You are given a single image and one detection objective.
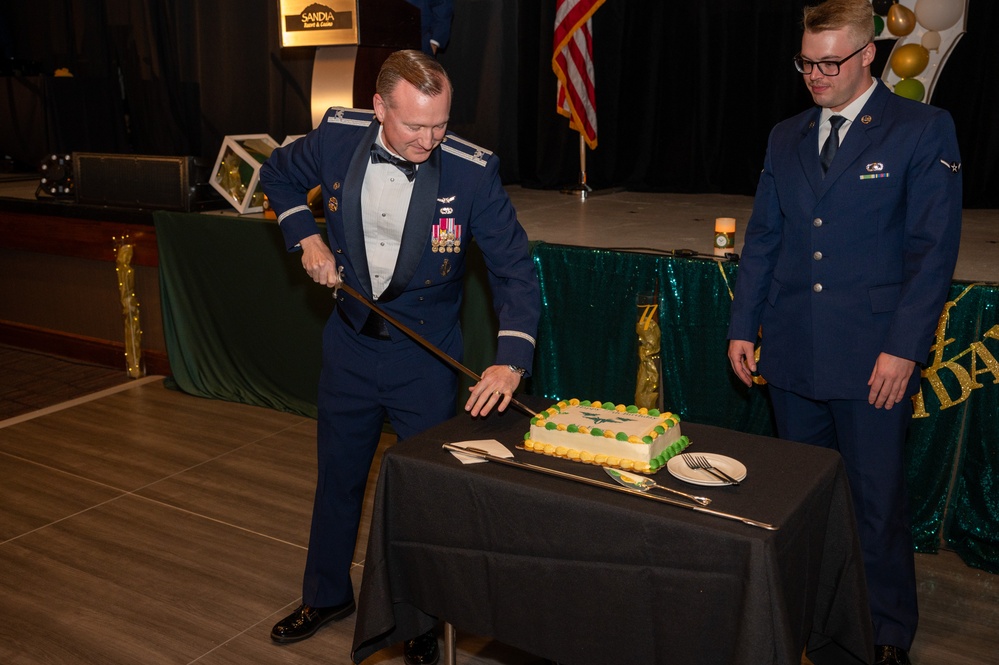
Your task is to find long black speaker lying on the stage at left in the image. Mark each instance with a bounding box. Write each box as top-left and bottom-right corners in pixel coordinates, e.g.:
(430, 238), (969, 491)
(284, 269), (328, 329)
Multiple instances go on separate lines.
(73, 152), (196, 211)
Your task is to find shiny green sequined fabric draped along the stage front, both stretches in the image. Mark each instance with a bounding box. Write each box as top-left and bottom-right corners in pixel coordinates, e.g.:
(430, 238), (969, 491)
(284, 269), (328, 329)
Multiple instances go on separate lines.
(533, 244), (999, 572)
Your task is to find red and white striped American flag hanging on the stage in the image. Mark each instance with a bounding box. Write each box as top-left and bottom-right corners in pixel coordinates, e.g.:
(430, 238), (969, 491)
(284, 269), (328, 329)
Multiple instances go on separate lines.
(552, 0), (604, 149)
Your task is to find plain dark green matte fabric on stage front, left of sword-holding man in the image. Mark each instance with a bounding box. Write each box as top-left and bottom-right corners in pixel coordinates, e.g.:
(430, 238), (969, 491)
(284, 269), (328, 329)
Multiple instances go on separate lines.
(153, 212), (333, 418)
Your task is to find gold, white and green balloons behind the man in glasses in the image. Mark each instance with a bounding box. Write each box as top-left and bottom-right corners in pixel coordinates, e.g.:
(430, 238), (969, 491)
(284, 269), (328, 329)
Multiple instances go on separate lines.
(871, 0), (970, 102)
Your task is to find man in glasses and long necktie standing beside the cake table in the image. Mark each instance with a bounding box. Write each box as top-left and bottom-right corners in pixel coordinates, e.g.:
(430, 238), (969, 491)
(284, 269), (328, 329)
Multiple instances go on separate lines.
(728, 5), (961, 664)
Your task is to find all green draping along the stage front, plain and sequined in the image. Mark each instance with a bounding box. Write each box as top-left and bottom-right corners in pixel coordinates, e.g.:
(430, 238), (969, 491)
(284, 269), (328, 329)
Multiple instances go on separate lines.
(154, 217), (999, 573)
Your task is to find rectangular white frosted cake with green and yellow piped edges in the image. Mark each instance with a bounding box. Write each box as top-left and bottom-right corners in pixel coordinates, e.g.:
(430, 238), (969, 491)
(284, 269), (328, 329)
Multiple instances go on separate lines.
(524, 399), (690, 473)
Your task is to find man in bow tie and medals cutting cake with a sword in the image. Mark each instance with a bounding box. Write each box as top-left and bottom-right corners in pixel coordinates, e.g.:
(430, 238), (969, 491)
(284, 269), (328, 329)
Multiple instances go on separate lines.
(260, 51), (540, 665)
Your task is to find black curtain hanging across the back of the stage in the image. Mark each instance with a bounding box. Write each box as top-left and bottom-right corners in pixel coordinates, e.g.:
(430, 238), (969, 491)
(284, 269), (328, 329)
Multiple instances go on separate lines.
(0, 0), (999, 208)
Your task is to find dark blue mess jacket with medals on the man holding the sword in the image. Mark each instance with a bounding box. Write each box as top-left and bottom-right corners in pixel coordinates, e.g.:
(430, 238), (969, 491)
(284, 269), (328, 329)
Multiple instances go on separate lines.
(260, 108), (541, 370)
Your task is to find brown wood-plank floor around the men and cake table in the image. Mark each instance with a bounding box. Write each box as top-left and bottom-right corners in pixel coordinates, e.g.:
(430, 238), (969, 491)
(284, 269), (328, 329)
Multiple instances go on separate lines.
(0, 367), (999, 665)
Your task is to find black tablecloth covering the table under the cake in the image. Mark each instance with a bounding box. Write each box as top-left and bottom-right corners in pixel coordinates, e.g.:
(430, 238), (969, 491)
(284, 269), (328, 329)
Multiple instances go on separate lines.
(353, 400), (872, 665)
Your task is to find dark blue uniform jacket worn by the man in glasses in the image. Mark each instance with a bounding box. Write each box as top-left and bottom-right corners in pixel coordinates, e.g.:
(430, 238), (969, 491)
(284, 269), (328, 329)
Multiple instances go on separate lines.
(728, 81), (961, 399)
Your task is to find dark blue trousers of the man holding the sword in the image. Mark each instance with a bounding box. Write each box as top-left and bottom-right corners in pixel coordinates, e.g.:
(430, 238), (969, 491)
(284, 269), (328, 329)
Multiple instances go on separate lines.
(302, 313), (462, 607)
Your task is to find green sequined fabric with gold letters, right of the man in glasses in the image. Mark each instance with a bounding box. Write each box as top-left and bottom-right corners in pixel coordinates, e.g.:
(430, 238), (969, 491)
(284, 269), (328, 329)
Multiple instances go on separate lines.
(908, 283), (999, 573)
